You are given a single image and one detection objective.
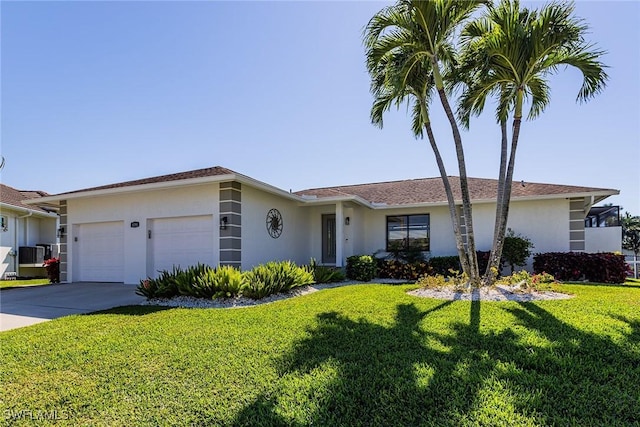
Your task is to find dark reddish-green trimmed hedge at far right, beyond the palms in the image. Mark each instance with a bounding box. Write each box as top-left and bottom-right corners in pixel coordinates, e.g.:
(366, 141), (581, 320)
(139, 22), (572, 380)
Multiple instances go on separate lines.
(533, 252), (629, 283)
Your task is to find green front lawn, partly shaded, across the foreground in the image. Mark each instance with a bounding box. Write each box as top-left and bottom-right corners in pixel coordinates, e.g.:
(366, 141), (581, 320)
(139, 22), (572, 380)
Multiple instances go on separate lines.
(0, 285), (640, 426)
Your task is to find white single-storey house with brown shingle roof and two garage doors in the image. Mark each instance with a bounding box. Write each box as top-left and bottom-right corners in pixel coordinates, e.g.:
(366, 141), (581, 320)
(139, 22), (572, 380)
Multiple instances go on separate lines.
(26, 167), (618, 283)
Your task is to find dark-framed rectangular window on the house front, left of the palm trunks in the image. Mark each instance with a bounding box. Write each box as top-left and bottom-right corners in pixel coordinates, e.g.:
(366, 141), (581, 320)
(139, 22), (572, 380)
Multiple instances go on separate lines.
(387, 214), (429, 251)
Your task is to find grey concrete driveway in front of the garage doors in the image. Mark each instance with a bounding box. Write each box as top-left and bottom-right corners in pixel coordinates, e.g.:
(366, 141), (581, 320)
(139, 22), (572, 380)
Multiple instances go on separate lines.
(0, 283), (145, 331)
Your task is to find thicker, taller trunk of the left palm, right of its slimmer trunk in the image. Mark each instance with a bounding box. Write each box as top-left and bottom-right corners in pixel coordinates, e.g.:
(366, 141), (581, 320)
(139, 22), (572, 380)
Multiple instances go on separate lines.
(432, 63), (480, 286)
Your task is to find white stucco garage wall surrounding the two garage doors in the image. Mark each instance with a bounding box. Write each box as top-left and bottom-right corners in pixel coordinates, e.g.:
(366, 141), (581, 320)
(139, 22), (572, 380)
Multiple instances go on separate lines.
(67, 183), (218, 284)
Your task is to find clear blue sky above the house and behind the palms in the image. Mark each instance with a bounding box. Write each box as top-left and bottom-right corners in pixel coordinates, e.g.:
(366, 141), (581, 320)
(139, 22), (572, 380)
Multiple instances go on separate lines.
(0, 1), (640, 214)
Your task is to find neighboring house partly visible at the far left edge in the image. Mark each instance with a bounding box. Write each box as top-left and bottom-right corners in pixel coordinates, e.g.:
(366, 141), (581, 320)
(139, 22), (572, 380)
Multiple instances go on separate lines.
(0, 184), (58, 279)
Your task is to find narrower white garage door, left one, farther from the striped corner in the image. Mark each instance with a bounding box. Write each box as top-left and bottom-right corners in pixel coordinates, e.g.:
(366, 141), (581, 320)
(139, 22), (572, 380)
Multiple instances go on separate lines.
(76, 221), (124, 282)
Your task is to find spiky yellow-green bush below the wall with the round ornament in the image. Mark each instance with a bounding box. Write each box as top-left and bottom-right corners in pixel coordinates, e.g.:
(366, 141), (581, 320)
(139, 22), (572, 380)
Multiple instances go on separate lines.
(242, 261), (313, 299)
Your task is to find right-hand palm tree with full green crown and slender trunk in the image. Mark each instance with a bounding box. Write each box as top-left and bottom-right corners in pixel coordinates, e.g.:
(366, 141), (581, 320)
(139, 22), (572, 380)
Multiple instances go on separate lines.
(458, 0), (608, 283)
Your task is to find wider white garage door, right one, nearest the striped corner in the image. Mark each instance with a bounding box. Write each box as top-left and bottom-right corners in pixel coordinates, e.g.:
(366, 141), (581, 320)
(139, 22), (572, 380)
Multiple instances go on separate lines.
(148, 215), (217, 277)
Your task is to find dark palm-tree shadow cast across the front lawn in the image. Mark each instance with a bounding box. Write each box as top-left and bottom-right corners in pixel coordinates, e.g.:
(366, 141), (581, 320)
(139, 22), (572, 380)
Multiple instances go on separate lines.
(234, 301), (640, 426)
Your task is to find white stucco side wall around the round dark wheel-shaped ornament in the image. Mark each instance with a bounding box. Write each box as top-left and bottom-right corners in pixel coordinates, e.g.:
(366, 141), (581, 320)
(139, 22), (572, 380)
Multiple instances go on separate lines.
(242, 185), (311, 270)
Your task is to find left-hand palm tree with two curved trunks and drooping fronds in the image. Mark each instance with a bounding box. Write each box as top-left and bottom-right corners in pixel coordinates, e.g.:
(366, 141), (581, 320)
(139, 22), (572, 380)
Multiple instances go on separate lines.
(365, 0), (484, 284)
